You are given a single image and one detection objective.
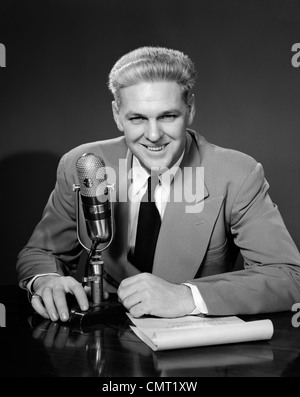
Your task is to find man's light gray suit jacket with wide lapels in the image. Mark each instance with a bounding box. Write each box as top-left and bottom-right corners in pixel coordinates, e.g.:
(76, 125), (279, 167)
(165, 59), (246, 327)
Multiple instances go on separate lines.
(17, 130), (300, 315)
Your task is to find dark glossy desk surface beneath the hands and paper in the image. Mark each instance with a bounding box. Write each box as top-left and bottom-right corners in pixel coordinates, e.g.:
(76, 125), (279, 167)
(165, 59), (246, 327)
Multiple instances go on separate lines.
(0, 287), (300, 377)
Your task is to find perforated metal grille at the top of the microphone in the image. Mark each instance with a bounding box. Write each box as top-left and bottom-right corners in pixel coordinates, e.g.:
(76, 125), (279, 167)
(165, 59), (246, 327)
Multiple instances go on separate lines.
(76, 153), (107, 197)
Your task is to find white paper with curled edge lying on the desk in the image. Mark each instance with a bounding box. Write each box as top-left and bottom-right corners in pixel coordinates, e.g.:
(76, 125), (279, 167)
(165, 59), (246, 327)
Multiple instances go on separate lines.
(128, 314), (274, 351)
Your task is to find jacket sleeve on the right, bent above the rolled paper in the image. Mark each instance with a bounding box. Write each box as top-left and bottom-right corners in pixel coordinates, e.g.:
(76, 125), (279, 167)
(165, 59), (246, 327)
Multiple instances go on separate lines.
(191, 163), (300, 315)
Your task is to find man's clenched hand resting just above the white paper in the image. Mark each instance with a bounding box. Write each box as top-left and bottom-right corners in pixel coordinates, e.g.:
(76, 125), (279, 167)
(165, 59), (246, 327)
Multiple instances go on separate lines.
(118, 273), (195, 317)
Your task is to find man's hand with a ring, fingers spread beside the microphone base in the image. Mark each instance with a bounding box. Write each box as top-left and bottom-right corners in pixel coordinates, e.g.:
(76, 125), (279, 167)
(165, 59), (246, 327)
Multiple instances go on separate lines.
(31, 275), (89, 321)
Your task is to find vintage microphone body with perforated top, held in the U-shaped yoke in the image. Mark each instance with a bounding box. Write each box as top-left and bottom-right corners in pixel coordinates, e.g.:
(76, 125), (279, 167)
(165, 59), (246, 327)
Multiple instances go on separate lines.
(76, 153), (112, 245)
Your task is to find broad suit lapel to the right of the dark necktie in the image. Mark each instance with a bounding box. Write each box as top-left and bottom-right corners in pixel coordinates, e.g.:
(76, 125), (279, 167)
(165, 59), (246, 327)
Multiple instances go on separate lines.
(153, 196), (223, 282)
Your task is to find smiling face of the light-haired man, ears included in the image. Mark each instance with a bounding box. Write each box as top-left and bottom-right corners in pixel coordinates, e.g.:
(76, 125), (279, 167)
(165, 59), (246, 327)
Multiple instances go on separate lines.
(113, 81), (195, 172)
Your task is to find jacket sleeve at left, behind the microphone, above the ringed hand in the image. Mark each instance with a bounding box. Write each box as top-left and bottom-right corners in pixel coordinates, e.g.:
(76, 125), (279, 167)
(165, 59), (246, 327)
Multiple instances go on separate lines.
(16, 155), (82, 287)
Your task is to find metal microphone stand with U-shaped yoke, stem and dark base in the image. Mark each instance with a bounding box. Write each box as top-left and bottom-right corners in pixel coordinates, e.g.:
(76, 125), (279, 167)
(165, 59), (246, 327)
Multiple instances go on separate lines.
(69, 184), (121, 325)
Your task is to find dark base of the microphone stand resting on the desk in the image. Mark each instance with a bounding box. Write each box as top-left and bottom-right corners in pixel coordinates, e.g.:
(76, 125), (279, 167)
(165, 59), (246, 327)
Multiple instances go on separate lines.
(69, 297), (125, 327)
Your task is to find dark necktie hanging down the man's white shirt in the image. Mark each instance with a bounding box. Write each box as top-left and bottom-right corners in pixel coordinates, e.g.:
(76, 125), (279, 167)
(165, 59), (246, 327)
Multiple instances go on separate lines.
(132, 176), (161, 273)
